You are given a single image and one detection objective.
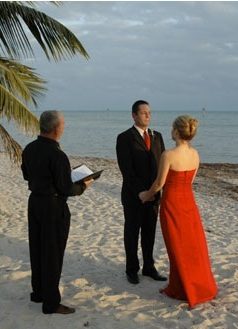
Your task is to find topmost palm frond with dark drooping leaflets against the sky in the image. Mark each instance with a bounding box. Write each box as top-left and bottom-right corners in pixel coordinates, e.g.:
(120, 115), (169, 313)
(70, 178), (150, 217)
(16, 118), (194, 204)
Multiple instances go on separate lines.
(0, 1), (89, 61)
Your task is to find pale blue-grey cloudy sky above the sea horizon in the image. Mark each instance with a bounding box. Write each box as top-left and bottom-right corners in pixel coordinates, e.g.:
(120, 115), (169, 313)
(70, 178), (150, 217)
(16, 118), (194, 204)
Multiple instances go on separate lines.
(24, 1), (238, 112)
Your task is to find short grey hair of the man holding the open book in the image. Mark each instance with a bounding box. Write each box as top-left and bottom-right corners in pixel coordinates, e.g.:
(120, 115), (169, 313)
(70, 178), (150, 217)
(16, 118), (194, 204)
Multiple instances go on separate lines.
(40, 110), (63, 133)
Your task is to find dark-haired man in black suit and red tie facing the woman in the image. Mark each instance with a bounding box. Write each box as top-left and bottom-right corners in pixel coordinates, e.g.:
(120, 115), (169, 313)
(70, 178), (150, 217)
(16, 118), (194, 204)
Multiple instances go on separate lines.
(116, 100), (166, 284)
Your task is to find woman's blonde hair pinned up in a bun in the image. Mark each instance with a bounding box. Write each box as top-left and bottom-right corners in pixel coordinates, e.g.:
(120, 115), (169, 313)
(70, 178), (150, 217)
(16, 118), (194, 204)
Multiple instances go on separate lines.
(173, 115), (198, 140)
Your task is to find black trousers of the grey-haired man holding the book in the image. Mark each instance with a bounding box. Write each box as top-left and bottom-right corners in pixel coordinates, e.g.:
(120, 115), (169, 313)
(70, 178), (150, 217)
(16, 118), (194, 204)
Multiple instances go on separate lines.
(28, 194), (70, 313)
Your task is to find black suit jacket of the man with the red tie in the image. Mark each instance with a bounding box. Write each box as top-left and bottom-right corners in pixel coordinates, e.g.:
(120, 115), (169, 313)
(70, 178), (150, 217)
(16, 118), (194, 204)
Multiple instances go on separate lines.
(116, 126), (165, 205)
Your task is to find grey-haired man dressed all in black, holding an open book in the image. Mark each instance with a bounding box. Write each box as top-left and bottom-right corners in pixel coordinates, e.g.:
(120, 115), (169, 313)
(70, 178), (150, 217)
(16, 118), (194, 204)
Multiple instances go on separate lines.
(21, 111), (93, 314)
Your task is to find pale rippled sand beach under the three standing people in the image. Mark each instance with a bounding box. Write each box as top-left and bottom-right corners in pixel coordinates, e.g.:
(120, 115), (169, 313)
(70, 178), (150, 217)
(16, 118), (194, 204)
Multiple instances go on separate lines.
(0, 153), (238, 329)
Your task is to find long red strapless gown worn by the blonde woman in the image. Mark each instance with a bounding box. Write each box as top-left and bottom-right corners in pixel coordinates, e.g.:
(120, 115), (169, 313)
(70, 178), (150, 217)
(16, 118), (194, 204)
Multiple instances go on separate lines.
(160, 169), (217, 307)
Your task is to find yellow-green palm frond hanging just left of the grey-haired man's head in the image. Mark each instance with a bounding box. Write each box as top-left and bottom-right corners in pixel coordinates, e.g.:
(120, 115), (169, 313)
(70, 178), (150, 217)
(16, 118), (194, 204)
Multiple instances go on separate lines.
(0, 84), (39, 134)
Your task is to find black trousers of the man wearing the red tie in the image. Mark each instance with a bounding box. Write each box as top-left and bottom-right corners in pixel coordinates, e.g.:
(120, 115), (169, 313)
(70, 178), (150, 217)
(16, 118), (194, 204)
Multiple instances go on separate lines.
(123, 203), (158, 274)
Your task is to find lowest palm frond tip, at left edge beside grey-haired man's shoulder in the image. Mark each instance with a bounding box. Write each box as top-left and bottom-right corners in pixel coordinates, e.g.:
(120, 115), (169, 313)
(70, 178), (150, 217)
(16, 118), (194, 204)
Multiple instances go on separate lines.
(0, 125), (22, 164)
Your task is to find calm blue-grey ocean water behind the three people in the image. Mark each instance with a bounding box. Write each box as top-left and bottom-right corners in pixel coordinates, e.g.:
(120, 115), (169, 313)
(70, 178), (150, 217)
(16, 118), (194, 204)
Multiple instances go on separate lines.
(2, 111), (238, 163)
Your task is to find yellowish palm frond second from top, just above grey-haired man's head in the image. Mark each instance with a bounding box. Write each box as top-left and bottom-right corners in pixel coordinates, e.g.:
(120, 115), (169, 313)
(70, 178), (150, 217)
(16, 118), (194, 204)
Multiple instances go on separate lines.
(0, 57), (46, 107)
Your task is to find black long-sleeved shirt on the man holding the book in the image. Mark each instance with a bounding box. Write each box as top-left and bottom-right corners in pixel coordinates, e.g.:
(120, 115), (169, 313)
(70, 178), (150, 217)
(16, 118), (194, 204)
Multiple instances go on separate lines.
(21, 136), (86, 199)
